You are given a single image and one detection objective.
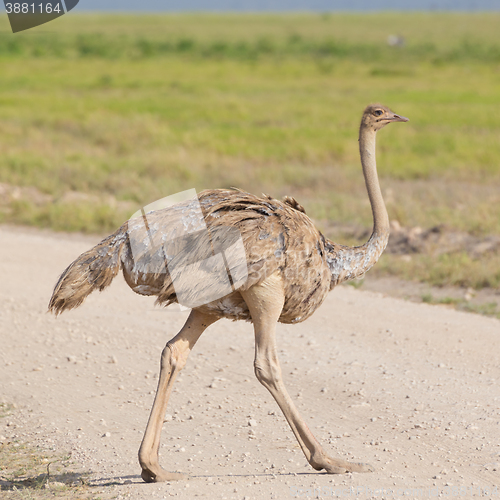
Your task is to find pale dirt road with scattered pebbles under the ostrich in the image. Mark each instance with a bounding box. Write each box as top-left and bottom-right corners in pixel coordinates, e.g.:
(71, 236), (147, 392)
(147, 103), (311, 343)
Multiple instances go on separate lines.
(0, 226), (500, 499)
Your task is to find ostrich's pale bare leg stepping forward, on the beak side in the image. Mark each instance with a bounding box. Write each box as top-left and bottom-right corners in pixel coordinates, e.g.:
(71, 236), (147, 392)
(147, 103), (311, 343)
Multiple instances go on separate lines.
(241, 275), (373, 474)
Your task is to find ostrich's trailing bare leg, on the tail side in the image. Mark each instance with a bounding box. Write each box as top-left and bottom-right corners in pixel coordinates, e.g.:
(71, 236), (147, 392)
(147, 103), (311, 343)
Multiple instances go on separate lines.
(139, 309), (218, 483)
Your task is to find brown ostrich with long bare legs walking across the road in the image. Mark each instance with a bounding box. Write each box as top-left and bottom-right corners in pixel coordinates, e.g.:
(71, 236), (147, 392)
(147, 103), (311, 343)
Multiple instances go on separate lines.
(49, 105), (408, 482)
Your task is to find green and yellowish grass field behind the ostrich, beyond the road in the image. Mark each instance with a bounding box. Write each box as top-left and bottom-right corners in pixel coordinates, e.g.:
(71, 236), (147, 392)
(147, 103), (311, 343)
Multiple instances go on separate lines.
(0, 13), (500, 288)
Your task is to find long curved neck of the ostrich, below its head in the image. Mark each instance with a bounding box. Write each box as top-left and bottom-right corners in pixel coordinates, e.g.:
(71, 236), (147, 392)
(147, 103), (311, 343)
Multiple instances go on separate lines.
(326, 125), (389, 288)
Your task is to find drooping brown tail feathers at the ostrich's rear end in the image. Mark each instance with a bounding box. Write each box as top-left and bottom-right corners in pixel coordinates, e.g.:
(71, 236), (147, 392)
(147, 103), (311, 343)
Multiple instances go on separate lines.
(49, 224), (127, 316)
